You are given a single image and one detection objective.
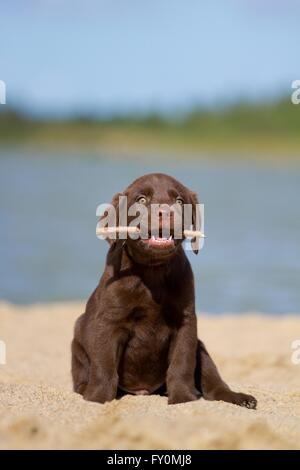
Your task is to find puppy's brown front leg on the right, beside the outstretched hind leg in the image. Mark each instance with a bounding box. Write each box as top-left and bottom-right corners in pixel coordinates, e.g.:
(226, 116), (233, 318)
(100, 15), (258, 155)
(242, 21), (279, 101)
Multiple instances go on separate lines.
(167, 313), (198, 404)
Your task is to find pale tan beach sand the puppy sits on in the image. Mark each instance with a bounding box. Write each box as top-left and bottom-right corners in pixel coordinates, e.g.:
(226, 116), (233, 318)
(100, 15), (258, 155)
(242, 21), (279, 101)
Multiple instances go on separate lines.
(0, 302), (300, 449)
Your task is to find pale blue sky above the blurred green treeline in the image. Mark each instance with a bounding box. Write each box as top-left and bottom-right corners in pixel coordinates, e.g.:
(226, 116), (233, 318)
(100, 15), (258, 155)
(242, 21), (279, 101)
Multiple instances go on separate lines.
(0, 0), (300, 115)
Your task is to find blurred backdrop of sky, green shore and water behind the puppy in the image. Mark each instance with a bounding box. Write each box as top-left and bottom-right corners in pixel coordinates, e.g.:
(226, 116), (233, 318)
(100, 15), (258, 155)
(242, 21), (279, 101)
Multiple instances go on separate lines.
(0, 0), (300, 313)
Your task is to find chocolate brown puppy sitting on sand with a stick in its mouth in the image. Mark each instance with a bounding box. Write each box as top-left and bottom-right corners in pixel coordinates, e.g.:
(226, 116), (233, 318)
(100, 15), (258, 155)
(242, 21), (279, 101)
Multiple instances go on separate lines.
(72, 173), (256, 408)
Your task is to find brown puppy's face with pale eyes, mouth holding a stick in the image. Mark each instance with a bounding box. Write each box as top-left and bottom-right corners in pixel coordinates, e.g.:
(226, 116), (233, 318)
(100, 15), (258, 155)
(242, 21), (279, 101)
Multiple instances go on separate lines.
(112, 173), (198, 264)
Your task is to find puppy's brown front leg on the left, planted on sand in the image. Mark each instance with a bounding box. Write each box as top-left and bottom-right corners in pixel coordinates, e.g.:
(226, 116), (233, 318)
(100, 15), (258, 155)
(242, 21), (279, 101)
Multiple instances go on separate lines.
(83, 327), (125, 403)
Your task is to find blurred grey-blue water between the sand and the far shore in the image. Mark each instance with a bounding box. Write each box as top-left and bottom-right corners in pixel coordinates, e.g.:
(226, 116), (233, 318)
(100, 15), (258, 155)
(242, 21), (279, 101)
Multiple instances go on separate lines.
(0, 150), (300, 313)
